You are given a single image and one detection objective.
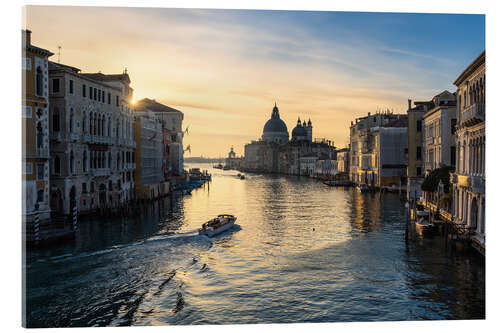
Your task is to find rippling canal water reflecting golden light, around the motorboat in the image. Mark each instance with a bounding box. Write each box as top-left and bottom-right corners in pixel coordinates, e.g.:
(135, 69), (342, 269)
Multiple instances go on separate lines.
(23, 165), (485, 327)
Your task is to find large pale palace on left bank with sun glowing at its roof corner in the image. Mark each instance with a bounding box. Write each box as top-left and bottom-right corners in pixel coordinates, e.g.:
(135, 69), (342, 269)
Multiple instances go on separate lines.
(49, 62), (135, 215)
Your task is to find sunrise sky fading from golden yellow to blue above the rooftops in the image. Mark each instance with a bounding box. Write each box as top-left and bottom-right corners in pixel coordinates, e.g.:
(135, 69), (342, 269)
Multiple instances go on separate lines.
(25, 6), (485, 157)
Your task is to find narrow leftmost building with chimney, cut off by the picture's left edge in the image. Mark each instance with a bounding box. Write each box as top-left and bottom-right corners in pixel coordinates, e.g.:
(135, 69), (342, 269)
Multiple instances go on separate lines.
(22, 30), (52, 222)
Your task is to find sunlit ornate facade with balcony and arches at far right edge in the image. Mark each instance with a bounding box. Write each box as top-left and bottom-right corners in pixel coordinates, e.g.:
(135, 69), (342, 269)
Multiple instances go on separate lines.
(451, 52), (486, 251)
